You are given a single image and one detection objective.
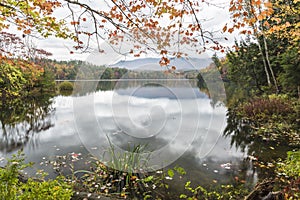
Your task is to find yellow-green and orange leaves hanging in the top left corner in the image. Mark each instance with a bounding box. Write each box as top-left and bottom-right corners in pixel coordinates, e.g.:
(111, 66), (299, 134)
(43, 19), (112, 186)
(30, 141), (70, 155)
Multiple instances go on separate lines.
(0, 0), (70, 38)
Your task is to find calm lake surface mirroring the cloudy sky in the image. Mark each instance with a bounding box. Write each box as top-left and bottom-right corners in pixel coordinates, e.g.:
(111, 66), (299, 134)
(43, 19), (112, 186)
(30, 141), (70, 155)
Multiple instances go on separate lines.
(0, 80), (257, 193)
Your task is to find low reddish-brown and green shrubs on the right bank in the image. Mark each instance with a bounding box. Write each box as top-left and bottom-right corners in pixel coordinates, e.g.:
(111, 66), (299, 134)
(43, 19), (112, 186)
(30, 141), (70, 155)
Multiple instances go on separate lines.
(224, 95), (300, 146)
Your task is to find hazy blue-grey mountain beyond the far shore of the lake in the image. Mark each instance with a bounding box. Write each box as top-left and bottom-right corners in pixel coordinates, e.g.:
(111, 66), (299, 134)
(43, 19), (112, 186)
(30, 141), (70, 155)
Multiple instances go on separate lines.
(109, 58), (212, 71)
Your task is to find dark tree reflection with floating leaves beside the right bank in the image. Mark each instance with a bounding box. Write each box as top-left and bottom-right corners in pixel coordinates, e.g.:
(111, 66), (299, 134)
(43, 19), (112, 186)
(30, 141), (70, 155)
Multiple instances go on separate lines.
(224, 108), (293, 179)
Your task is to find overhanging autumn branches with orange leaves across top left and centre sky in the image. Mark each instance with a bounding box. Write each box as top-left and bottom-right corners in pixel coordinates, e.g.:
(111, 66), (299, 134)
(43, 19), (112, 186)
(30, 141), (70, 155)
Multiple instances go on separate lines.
(0, 0), (227, 65)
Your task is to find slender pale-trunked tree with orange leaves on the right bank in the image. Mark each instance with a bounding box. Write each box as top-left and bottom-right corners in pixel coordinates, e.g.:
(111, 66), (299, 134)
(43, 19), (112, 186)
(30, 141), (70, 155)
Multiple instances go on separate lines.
(223, 0), (279, 92)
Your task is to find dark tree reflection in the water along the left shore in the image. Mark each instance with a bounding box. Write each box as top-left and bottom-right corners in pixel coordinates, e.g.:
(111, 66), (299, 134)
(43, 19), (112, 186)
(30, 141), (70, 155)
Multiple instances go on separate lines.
(0, 94), (54, 152)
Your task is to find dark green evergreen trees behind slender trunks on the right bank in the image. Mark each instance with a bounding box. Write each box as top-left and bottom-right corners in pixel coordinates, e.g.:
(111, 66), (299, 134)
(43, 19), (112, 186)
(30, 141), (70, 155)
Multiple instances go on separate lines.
(221, 30), (300, 97)
